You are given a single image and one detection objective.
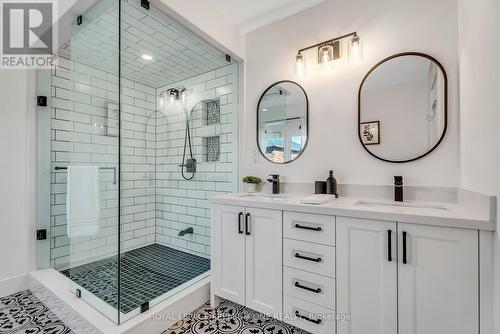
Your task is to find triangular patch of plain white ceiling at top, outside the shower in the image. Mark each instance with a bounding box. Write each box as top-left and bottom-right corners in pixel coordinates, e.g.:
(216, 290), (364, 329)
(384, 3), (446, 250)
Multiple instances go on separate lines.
(205, 0), (326, 33)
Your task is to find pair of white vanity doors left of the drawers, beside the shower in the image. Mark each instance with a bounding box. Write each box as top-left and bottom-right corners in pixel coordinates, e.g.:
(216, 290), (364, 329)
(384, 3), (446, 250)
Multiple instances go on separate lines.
(212, 205), (283, 315)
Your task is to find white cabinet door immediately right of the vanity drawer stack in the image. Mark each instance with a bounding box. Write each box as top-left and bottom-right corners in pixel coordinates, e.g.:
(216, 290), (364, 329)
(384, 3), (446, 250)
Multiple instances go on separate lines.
(337, 217), (398, 334)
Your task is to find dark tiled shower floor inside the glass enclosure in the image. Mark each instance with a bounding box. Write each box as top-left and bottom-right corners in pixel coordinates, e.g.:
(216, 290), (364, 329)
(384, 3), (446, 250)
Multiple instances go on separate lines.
(62, 244), (210, 313)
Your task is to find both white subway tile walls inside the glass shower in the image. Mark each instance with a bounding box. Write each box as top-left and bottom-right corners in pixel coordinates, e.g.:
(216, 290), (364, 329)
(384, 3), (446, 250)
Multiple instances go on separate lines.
(51, 59), (237, 268)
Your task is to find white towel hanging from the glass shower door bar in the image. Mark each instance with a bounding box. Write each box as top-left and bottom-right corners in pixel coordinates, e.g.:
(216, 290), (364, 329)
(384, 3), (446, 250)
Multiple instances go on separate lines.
(66, 166), (100, 238)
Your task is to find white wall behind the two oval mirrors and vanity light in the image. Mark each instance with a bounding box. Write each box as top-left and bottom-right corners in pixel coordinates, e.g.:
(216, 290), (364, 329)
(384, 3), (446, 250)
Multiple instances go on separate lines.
(240, 0), (459, 187)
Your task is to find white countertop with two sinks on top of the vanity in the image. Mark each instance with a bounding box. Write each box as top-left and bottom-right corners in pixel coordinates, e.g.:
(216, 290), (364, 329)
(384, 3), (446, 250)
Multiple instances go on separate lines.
(209, 193), (496, 231)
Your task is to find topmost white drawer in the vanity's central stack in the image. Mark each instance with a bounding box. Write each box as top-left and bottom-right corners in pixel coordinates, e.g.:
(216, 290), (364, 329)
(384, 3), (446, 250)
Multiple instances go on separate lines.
(283, 211), (335, 246)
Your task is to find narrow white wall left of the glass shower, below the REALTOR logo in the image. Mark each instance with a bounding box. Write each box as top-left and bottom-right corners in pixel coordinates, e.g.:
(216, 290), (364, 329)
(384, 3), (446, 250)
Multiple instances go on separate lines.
(0, 70), (35, 280)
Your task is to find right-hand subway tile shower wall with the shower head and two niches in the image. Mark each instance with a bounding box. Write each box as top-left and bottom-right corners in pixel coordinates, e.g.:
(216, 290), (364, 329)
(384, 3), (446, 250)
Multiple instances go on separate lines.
(156, 64), (237, 257)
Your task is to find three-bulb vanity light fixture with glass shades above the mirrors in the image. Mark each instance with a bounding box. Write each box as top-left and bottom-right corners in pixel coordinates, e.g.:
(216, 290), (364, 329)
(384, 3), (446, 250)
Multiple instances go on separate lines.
(295, 32), (361, 76)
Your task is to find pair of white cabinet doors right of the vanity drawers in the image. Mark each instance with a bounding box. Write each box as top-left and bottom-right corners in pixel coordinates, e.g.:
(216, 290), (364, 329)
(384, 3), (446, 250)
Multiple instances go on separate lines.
(337, 217), (479, 334)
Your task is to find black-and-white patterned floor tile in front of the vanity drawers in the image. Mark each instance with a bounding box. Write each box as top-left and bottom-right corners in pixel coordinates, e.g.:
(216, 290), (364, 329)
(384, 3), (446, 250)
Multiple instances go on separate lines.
(162, 301), (308, 334)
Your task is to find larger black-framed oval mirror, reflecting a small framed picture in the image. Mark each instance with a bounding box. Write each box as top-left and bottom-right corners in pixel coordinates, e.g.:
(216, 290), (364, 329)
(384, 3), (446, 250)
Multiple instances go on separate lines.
(358, 52), (448, 163)
